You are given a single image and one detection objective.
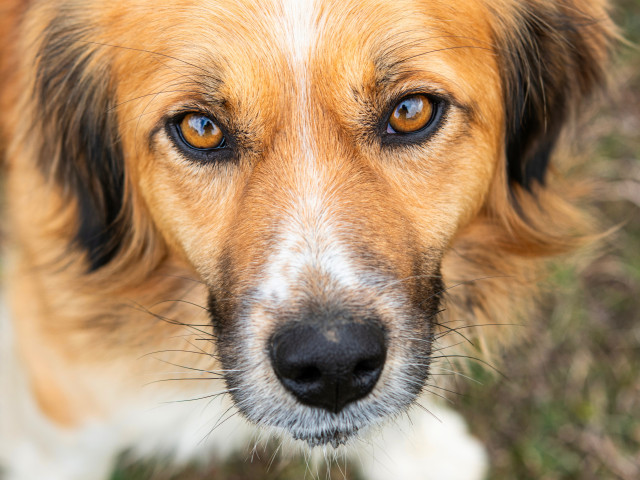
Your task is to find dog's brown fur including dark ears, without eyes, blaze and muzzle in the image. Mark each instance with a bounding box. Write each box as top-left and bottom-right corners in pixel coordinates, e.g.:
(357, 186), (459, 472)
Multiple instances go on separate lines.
(0, 0), (612, 462)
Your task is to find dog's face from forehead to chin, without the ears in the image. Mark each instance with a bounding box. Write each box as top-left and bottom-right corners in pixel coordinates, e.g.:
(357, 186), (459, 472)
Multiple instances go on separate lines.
(109, 1), (504, 444)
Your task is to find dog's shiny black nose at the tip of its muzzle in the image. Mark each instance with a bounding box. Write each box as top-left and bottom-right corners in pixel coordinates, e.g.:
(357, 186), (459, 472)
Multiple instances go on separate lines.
(271, 322), (387, 413)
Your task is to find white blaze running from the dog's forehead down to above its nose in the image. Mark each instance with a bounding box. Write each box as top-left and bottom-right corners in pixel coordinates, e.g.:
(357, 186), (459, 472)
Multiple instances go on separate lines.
(258, 0), (368, 303)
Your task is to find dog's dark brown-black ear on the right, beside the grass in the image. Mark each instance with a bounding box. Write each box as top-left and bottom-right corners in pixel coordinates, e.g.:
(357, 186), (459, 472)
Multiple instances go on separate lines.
(495, 0), (613, 191)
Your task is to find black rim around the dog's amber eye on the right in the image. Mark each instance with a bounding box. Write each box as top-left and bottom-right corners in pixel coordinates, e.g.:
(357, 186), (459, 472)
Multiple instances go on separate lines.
(378, 91), (449, 146)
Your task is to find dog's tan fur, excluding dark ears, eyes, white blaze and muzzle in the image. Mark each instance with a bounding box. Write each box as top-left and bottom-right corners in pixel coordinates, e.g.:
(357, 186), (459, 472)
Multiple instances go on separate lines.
(0, 0), (611, 468)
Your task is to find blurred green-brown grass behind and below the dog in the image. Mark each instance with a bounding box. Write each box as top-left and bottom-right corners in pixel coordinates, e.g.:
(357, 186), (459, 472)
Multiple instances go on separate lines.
(112, 0), (640, 480)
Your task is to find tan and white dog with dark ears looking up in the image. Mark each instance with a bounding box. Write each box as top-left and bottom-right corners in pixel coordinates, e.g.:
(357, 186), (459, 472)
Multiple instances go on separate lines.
(0, 0), (614, 480)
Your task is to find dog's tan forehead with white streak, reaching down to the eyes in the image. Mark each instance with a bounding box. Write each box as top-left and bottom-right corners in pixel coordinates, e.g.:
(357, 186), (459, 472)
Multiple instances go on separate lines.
(102, 0), (497, 136)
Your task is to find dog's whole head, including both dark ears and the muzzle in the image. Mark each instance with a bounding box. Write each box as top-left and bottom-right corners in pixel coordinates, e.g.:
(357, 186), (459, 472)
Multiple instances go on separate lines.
(10, 0), (604, 445)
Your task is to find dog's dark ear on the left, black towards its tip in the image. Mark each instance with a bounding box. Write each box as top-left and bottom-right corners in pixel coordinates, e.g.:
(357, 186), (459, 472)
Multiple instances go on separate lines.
(35, 16), (124, 271)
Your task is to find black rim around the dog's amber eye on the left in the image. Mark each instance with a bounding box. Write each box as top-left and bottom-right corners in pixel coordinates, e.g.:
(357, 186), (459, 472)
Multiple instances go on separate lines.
(165, 110), (234, 163)
